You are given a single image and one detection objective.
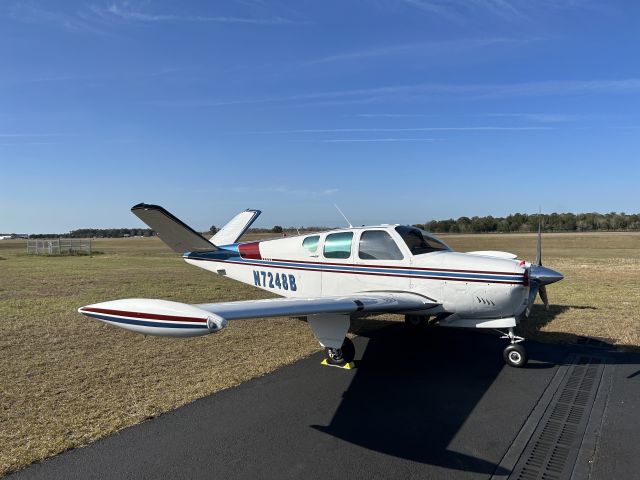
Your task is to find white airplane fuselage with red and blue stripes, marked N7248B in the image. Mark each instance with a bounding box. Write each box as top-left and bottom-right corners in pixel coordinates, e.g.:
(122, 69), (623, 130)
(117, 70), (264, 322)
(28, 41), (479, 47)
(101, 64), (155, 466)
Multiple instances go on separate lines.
(184, 225), (529, 327)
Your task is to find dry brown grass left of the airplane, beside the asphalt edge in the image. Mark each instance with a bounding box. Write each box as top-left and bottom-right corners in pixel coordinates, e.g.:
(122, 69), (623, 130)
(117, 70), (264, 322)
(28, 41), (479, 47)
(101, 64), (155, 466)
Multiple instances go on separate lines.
(0, 238), (318, 475)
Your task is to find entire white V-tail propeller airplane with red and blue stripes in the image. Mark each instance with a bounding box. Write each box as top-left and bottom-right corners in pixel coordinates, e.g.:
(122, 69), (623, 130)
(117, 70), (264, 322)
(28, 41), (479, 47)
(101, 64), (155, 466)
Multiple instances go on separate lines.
(78, 203), (563, 368)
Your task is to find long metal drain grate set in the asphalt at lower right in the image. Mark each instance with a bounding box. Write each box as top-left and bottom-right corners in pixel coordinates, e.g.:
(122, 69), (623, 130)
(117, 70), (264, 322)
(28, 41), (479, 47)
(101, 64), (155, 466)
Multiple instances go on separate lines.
(509, 355), (604, 480)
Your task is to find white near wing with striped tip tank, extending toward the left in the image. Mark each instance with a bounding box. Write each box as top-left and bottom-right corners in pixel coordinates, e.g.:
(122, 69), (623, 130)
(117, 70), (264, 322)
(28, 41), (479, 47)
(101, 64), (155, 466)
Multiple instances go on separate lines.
(78, 292), (440, 337)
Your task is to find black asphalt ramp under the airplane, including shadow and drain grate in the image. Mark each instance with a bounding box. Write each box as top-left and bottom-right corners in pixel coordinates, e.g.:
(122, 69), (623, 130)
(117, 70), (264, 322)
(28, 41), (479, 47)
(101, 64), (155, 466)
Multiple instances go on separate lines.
(11, 324), (640, 480)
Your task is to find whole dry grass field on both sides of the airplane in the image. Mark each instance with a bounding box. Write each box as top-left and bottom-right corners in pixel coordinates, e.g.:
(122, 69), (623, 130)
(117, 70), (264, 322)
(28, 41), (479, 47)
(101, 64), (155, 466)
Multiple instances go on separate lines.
(0, 233), (640, 475)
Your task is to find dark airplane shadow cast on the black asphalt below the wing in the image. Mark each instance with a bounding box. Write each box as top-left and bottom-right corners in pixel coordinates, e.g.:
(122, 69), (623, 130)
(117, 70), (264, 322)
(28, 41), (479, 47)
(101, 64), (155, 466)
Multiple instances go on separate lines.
(312, 320), (576, 475)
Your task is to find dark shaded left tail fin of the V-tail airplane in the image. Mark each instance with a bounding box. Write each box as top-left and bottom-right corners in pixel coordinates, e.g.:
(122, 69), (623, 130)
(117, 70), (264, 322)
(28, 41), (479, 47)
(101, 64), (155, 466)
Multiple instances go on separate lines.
(131, 203), (217, 253)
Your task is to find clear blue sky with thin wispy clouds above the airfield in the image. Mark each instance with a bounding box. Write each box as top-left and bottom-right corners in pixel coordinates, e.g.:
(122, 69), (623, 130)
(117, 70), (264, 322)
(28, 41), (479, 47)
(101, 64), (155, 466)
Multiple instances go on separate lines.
(0, 0), (640, 233)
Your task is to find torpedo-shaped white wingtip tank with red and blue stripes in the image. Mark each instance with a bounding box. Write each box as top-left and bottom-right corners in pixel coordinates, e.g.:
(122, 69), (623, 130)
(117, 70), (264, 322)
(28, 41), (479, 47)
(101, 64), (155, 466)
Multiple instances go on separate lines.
(78, 298), (227, 337)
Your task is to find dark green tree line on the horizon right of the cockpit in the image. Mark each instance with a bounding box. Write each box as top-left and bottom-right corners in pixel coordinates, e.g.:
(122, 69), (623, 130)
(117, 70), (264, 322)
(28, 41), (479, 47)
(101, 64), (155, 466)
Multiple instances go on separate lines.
(415, 212), (640, 233)
